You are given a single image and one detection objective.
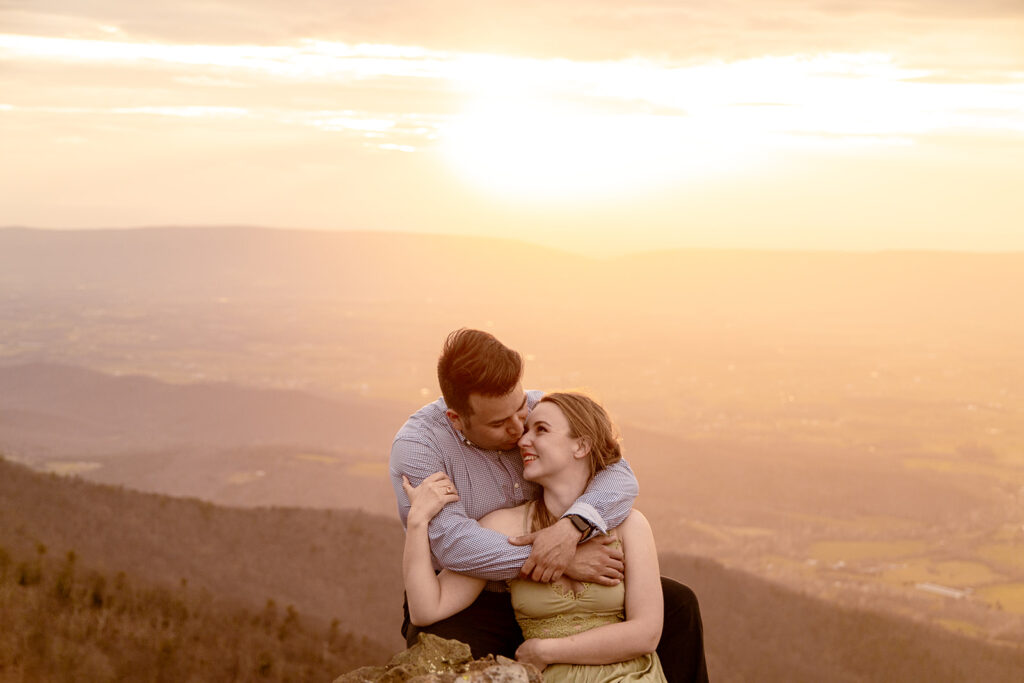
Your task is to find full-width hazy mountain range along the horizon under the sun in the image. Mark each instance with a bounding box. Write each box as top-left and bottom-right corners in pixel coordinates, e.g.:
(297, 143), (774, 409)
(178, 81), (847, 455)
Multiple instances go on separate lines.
(0, 227), (1024, 323)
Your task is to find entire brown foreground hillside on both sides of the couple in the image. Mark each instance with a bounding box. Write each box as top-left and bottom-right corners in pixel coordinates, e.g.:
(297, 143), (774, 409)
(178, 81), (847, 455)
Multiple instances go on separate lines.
(0, 461), (1024, 682)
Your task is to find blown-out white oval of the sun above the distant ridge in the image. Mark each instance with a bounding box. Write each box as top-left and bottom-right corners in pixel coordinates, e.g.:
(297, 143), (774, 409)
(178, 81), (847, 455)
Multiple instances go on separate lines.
(442, 93), (729, 203)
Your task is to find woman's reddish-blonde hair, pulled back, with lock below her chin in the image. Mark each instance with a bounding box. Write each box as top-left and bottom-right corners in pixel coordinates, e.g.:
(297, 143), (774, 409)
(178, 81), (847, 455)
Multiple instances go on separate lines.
(531, 391), (623, 530)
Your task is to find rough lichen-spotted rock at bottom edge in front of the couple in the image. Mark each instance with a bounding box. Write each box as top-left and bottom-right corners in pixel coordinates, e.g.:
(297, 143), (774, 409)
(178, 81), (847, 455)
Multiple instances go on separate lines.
(334, 633), (544, 683)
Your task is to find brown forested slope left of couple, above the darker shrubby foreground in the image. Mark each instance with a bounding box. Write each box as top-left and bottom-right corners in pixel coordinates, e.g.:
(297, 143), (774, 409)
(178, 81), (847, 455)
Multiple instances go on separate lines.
(0, 461), (401, 650)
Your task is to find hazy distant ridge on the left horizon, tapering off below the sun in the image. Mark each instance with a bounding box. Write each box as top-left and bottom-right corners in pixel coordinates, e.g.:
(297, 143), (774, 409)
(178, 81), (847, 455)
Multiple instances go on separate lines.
(0, 227), (590, 302)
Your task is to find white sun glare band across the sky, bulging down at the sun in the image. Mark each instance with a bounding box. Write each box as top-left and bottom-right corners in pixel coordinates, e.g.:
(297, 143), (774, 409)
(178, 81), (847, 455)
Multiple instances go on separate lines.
(8, 29), (1024, 214)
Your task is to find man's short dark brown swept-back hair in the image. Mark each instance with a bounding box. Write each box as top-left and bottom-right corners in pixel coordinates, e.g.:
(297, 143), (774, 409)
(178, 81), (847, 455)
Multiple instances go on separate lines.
(437, 328), (522, 420)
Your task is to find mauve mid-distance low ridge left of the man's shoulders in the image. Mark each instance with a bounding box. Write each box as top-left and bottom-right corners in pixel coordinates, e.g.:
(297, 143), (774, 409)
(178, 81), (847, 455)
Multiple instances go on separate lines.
(0, 364), (401, 457)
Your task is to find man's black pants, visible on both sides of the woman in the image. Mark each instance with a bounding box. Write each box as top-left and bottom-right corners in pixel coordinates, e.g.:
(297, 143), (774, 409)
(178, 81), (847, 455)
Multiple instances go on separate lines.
(401, 577), (708, 683)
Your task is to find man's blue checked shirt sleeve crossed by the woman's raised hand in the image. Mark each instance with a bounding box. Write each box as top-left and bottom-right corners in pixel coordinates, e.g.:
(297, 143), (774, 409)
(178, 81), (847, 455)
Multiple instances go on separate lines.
(389, 439), (532, 581)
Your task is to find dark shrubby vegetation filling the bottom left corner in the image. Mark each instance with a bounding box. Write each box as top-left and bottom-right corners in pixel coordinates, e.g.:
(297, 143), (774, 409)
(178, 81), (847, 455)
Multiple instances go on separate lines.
(0, 544), (385, 683)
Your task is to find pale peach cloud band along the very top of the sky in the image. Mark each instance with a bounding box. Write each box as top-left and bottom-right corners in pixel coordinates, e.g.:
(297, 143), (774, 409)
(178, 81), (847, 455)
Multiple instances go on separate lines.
(8, 0), (1024, 70)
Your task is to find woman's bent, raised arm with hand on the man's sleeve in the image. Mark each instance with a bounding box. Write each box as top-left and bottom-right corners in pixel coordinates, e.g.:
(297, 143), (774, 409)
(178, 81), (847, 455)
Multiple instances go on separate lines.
(401, 472), (486, 626)
